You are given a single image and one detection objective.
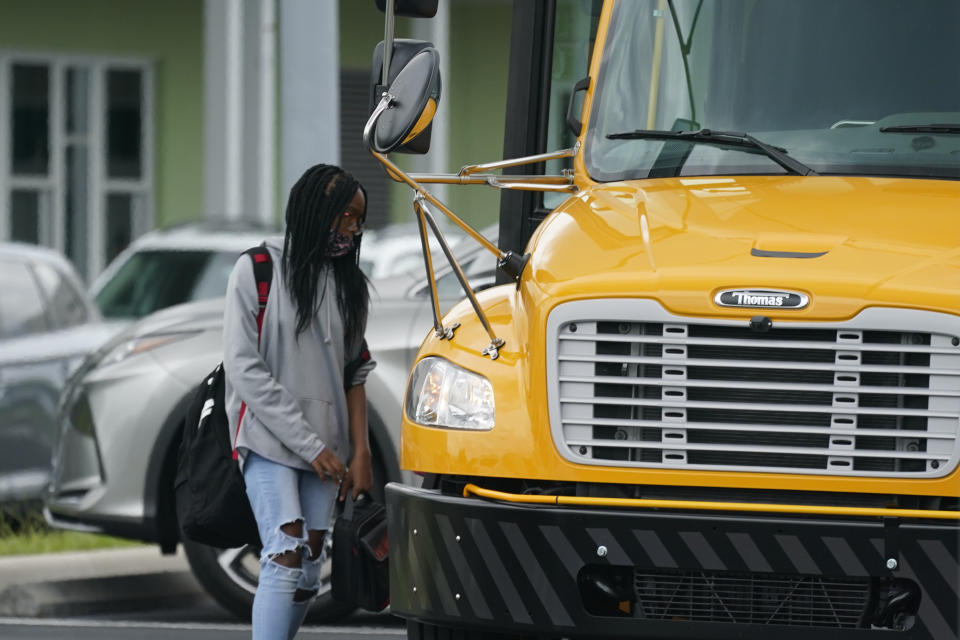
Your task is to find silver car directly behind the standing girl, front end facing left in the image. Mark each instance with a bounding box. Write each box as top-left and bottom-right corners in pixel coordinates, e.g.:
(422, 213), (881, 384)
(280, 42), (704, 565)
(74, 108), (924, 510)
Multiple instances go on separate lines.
(45, 239), (495, 621)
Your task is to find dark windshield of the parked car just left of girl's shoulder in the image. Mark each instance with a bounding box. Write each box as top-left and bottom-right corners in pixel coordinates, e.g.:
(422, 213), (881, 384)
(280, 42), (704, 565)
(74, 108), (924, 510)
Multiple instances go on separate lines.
(96, 250), (238, 318)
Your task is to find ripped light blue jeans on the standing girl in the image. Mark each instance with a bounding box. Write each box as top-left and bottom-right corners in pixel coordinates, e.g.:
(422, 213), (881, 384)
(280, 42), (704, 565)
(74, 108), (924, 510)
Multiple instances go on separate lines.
(243, 451), (338, 640)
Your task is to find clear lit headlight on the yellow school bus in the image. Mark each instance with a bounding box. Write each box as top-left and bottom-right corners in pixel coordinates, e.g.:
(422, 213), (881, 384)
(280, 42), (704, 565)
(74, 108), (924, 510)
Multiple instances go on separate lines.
(406, 357), (494, 431)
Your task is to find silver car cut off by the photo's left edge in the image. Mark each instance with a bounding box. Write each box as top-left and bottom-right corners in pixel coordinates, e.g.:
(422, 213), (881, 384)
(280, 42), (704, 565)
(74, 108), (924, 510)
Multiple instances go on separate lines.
(0, 243), (109, 503)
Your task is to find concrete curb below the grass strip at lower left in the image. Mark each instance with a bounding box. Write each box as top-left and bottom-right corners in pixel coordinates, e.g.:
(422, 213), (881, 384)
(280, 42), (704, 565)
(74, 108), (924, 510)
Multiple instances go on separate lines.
(0, 545), (210, 617)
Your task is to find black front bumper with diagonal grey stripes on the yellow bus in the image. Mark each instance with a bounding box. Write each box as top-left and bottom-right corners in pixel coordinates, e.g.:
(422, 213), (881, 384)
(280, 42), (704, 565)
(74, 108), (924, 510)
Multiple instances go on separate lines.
(387, 484), (960, 640)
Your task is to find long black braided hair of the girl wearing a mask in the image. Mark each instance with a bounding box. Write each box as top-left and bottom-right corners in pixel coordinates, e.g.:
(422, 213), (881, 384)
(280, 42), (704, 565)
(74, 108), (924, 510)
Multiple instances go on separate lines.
(282, 164), (370, 345)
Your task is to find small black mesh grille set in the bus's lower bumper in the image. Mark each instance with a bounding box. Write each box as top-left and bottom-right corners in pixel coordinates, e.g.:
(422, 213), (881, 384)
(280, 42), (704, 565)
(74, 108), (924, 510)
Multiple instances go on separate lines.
(634, 570), (870, 628)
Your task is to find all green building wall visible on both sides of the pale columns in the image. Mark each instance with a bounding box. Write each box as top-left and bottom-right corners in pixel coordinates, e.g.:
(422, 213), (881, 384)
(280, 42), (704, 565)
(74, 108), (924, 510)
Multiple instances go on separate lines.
(0, 0), (511, 241)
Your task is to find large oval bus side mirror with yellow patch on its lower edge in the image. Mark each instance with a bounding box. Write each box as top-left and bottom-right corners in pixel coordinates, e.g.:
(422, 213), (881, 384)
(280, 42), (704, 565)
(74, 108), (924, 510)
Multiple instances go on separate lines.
(363, 47), (440, 154)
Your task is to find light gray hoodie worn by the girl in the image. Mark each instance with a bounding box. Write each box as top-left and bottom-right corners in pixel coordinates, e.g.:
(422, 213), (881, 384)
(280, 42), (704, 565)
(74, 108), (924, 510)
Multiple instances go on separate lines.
(223, 240), (376, 469)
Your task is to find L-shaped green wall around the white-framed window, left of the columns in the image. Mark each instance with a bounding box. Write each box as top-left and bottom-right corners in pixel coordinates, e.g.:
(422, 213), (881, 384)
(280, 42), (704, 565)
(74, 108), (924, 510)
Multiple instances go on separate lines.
(0, 0), (203, 227)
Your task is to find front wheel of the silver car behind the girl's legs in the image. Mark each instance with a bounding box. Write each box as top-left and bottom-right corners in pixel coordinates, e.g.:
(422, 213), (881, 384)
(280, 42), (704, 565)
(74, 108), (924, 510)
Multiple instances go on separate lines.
(183, 452), (386, 624)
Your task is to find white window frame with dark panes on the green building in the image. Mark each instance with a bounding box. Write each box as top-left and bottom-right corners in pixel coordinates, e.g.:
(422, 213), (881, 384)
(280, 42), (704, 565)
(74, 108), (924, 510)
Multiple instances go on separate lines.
(0, 49), (156, 282)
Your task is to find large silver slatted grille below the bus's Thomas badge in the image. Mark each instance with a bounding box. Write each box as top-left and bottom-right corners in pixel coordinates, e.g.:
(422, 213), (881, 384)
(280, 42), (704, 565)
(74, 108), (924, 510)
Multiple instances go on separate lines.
(548, 303), (960, 477)
